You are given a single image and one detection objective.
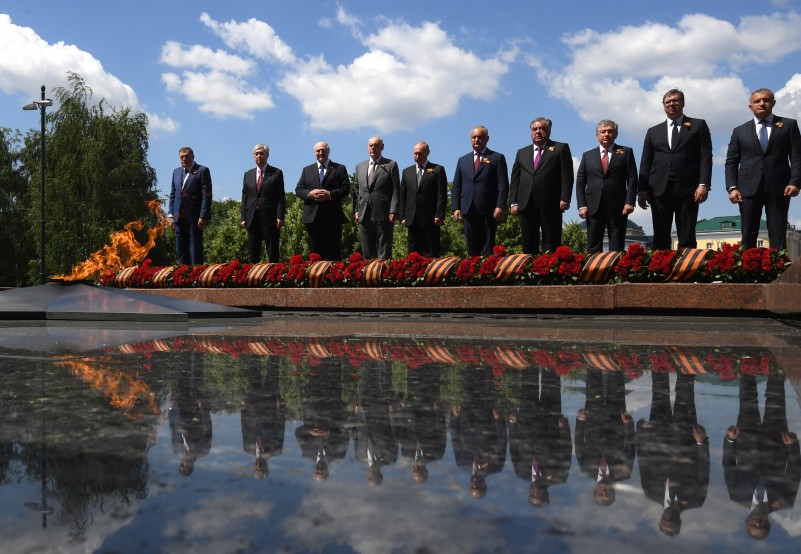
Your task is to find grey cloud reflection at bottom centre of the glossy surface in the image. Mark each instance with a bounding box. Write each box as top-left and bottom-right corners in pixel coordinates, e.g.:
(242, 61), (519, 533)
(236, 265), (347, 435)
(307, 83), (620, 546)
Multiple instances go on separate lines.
(284, 482), (506, 553)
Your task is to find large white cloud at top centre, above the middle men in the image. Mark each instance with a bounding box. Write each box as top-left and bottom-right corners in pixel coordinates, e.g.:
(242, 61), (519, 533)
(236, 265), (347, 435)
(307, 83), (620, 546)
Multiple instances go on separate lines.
(279, 19), (510, 132)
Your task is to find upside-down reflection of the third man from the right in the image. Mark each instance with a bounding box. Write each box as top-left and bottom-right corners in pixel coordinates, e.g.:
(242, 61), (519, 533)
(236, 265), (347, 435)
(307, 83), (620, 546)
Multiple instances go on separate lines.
(575, 369), (636, 506)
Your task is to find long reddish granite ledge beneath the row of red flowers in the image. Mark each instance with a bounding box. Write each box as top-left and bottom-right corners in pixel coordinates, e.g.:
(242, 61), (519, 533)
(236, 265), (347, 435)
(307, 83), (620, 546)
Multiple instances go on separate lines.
(130, 283), (776, 314)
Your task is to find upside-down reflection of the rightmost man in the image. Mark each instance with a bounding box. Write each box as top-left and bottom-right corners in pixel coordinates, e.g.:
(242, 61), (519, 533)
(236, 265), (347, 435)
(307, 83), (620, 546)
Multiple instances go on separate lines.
(723, 375), (801, 539)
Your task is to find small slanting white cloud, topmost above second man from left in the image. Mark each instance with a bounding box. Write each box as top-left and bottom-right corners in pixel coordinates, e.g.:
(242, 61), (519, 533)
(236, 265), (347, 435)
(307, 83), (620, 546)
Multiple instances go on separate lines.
(200, 13), (295, 64)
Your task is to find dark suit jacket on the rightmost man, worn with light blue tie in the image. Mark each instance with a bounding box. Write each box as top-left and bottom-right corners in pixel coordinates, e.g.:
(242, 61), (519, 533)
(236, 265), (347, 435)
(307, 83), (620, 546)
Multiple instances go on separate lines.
(726, 115), (801, 197)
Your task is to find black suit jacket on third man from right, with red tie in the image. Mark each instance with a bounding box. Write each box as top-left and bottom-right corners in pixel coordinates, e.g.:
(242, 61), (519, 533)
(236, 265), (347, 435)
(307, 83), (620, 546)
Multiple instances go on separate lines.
(576, 144), (637, 215)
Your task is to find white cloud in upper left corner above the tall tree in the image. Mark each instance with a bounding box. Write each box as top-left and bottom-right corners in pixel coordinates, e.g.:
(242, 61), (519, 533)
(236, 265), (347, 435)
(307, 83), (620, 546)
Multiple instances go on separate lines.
(0, 14), (176, 135)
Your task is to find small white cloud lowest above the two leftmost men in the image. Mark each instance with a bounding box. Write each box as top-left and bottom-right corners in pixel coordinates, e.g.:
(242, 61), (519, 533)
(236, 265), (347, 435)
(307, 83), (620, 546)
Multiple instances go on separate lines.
(161, 70), (274, 119)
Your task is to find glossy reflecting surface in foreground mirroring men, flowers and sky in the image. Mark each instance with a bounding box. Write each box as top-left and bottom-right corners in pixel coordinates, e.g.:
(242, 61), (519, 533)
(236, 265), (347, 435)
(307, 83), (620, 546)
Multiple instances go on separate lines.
(0, 314), (801, 553)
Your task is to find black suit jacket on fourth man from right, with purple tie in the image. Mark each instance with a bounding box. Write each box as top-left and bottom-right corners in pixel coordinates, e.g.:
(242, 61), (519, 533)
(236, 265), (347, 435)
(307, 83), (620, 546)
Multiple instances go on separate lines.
(510, 140), (573, 212)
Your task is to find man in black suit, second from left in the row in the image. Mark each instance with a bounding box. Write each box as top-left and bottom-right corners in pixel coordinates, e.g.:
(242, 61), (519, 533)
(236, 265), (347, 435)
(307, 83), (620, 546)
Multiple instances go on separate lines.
(240, 144), (286, 264)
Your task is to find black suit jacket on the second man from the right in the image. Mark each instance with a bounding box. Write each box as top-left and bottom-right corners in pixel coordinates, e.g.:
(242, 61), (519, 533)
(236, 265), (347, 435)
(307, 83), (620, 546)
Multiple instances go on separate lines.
(639, 116), (712, 197)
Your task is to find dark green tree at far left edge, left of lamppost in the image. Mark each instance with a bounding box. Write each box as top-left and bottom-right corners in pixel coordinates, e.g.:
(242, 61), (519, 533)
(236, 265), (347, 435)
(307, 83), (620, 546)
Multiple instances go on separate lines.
(0, 128), (38, 286)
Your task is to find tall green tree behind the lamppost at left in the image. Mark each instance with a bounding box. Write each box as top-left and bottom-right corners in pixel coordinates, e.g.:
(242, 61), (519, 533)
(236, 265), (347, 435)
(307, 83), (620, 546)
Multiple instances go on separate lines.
(23, 73), (158, 277)
